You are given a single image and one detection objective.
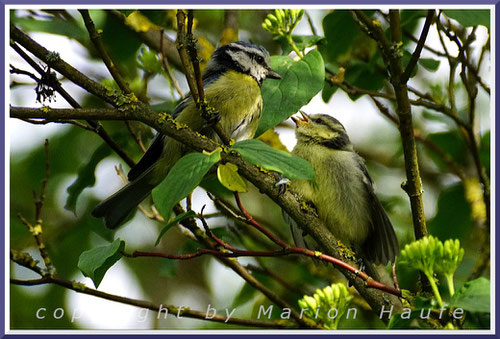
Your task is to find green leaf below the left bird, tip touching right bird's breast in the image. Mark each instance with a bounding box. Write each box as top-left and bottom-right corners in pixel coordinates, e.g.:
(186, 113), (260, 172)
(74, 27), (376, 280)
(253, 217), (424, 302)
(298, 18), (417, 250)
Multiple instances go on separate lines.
(230, 139), (314, 180)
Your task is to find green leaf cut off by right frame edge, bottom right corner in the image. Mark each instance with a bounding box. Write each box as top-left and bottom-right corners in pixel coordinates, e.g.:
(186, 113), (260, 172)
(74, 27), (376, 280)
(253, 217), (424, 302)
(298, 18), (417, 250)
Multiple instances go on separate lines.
(450, 277), (491, 313)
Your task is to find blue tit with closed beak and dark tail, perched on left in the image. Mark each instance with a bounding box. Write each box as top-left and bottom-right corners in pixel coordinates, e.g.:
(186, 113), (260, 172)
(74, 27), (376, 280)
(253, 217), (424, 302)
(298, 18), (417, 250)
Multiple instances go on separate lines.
(92, 41), (281, 229)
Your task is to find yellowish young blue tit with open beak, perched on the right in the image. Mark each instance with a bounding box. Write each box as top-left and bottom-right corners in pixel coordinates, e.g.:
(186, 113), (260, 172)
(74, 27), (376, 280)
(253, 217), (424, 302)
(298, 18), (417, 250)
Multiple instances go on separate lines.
(285, 112), (399, 280)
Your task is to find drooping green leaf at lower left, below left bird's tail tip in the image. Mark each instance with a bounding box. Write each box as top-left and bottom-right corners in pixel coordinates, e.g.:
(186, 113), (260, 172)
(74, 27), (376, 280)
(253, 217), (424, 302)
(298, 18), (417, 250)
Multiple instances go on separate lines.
(78, 239), (125, 288)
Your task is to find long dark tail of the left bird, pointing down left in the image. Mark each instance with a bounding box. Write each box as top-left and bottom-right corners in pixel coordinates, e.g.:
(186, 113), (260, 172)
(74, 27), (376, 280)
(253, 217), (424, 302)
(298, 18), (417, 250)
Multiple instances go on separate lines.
(92, 175), (154, 229)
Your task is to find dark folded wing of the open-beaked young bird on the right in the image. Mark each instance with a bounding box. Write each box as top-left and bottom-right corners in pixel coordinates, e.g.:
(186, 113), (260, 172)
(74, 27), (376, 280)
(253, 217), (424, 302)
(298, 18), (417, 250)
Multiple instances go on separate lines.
(358, 157), (399, 265)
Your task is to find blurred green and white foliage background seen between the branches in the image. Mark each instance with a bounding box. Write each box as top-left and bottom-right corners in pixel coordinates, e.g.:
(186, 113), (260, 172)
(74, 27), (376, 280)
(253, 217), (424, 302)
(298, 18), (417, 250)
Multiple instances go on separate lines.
(9, 10), (490, 329)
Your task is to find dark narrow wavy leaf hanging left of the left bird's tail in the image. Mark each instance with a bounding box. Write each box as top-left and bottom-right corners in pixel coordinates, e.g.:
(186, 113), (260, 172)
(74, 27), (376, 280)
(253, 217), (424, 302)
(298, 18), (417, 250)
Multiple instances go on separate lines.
(64, 144), (111, 213)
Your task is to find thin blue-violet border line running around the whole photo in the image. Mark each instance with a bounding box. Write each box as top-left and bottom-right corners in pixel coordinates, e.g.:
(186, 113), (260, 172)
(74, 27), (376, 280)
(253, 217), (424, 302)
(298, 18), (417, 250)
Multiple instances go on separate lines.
(0, 0), (500, 339)
